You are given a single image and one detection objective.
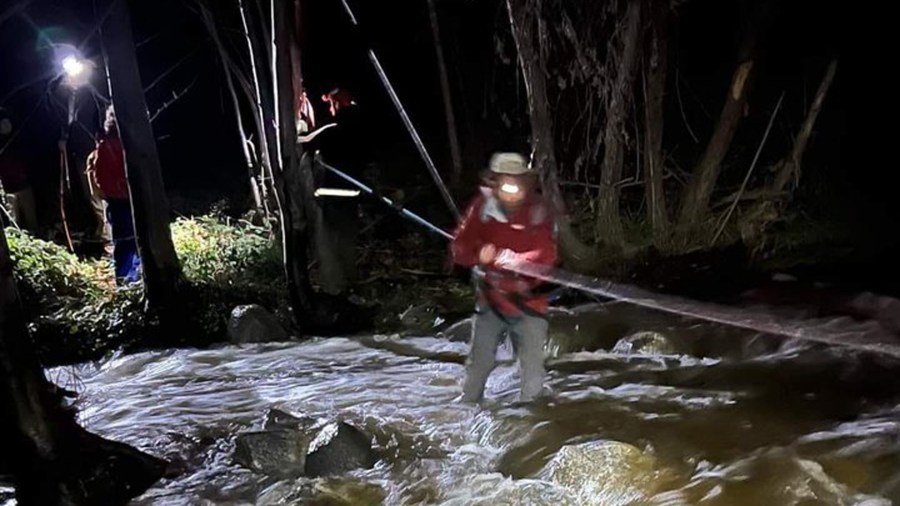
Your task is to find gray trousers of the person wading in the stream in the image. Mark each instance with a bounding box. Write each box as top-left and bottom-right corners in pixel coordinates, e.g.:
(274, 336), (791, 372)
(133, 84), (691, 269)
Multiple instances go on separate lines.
(463, 308), (548, 402)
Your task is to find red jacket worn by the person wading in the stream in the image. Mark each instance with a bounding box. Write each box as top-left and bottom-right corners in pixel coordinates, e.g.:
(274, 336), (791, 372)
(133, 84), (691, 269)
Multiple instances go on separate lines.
(450, 192), (557, 316)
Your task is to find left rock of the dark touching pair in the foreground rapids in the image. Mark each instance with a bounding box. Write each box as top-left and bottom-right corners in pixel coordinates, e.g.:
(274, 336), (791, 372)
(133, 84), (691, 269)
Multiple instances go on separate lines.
(234, 429), (310, 477)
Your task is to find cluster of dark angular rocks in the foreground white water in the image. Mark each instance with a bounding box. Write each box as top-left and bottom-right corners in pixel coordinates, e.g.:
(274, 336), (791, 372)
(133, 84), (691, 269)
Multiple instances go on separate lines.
(235, 409), (378, 477)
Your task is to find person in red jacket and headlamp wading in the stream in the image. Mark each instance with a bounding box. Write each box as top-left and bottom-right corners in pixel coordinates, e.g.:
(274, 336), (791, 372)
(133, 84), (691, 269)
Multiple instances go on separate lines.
(450, 153), (557, 403)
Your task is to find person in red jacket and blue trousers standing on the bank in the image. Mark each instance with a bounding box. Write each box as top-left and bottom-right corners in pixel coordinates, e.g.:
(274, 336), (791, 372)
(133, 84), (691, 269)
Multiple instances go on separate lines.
(87, 107), (141, 285)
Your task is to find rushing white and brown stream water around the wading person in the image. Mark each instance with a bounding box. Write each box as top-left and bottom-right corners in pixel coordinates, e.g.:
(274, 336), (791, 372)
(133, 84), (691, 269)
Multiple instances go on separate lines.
(35, 304), (900, 506)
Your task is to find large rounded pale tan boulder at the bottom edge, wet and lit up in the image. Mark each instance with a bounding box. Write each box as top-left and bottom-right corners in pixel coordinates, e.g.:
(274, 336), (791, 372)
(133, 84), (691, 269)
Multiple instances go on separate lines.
(542, 441), (657, 506)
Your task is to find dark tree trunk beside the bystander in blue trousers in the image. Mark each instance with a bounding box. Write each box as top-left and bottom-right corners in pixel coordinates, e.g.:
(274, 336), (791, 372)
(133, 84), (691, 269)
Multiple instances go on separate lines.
(101, 0), (181, 310)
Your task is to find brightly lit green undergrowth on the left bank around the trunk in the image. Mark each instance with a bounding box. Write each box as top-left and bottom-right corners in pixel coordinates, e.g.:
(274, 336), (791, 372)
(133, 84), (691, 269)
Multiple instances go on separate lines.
(6, 217), (286, 363)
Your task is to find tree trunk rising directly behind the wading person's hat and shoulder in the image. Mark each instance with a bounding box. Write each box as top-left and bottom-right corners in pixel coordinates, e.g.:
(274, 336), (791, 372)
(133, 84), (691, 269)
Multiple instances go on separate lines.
(506, 0), (598, 271)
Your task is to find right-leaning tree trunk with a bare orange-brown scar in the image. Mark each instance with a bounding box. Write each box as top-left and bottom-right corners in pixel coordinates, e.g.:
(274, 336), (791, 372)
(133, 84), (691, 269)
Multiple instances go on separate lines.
(678, 2), (766, 235)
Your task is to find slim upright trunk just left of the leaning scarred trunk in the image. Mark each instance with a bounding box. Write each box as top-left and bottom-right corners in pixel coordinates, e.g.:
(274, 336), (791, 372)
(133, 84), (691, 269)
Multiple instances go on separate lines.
(644, 0), (669, 244)
